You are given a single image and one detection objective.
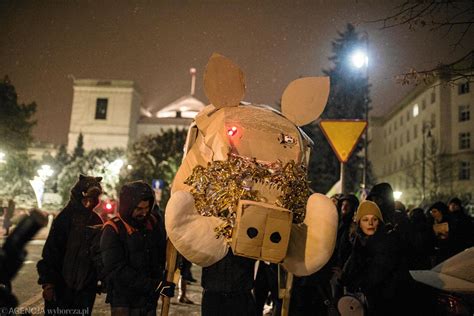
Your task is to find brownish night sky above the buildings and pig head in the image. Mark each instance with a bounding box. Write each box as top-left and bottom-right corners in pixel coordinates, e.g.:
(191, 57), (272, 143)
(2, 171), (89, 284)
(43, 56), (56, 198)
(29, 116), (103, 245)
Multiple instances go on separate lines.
(0, 0), (474, 144)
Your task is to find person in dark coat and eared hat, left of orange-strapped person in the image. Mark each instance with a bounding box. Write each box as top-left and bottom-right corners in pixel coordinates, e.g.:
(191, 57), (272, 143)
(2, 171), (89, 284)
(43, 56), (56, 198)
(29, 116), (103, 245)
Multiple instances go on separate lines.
(37, 175), (102, 315)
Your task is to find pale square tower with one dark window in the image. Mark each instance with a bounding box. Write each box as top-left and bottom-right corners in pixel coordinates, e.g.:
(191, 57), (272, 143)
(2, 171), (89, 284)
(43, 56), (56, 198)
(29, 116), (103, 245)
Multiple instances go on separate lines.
(68, 79), (142, 152)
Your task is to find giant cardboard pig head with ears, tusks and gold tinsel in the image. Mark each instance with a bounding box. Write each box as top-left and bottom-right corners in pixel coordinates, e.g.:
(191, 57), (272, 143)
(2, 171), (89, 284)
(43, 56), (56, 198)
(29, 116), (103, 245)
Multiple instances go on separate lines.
(165, 54), (338, 276)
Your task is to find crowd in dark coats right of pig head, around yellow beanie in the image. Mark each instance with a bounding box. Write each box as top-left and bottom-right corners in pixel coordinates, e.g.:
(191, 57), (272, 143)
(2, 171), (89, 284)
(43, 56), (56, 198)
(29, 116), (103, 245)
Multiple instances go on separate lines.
(256, 183), (474, 315)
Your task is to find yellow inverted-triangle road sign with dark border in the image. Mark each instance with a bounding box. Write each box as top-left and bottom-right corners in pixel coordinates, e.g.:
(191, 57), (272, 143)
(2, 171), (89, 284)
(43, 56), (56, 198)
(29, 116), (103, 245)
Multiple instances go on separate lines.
(319, 120), (367, 163)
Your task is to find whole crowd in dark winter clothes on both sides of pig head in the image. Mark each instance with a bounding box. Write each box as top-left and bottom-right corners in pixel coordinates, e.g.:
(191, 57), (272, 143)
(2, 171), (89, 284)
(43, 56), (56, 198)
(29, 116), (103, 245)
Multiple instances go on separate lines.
(3, 175), (466, 315)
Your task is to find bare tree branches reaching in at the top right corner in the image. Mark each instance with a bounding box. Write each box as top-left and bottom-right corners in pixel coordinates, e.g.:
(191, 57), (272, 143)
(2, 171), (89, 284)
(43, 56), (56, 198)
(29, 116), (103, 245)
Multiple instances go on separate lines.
(369, 0), (474, 84)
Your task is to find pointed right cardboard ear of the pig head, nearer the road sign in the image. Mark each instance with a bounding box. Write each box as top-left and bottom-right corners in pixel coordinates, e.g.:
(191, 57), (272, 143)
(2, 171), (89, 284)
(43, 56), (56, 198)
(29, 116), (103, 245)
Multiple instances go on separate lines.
(281, 77), (329, 126)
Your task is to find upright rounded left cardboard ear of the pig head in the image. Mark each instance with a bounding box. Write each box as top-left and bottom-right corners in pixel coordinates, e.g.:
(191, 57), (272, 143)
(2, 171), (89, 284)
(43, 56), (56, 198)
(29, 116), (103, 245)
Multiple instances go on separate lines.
(204, 53), (245, 108)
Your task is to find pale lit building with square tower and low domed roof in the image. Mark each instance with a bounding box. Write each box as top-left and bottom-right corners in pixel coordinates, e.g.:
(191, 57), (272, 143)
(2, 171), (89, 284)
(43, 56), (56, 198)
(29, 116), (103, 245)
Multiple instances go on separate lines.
(67, 79), (204, 152)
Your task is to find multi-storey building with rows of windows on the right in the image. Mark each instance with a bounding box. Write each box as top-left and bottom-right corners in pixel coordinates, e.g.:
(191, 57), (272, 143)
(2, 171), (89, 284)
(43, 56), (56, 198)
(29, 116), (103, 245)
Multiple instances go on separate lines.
(369, 79), (474, 206)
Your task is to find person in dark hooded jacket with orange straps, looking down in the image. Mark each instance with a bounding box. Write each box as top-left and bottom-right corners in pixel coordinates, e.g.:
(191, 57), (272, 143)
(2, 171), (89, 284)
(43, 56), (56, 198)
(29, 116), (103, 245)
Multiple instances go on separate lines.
(100, 181), (175, 316)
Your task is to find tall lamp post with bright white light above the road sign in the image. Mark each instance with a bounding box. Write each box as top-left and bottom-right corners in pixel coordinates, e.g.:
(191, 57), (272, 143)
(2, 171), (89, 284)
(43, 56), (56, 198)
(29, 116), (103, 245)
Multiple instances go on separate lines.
(351, 31), (369, 191)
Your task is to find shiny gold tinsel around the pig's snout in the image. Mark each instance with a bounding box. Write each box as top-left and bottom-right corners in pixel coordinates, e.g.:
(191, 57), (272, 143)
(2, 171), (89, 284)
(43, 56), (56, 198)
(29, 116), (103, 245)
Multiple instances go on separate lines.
(185, 154), (311, 240)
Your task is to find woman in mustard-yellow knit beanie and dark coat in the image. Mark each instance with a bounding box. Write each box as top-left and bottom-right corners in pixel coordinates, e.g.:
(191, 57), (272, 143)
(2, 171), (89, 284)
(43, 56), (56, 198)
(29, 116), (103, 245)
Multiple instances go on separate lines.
(341, 201), (412, 315)
